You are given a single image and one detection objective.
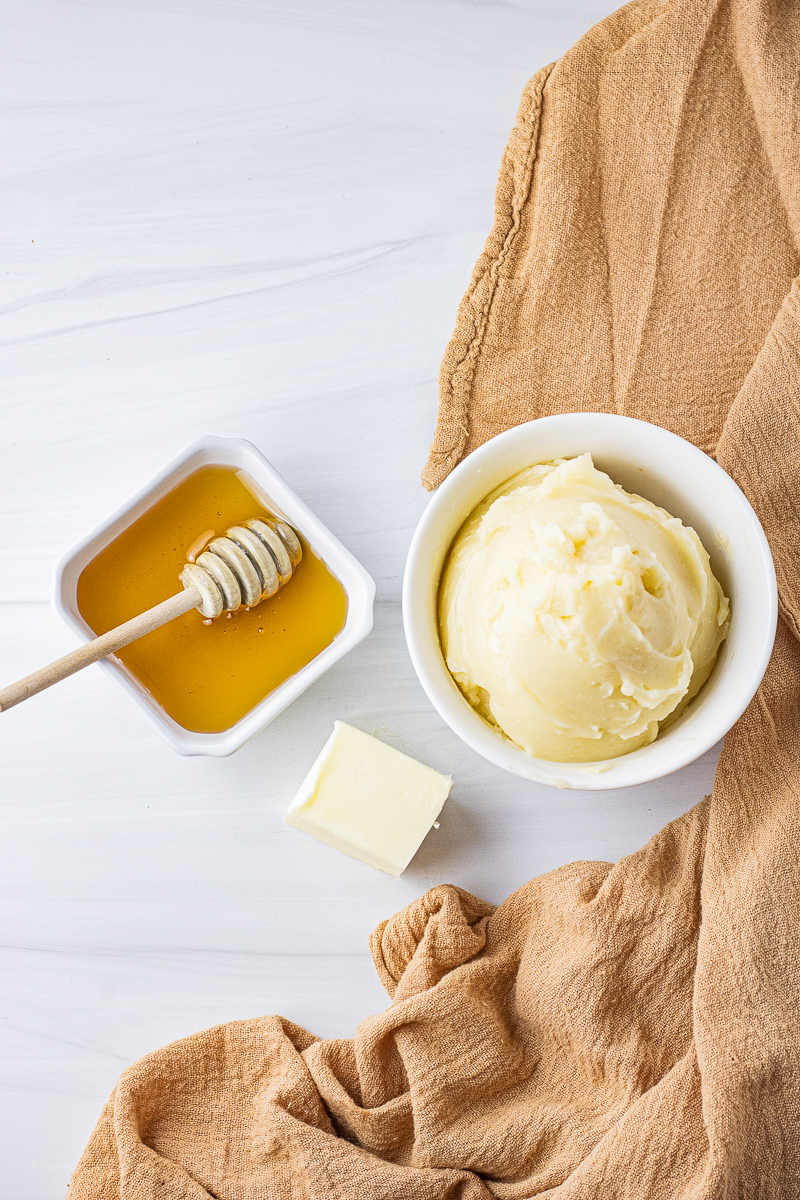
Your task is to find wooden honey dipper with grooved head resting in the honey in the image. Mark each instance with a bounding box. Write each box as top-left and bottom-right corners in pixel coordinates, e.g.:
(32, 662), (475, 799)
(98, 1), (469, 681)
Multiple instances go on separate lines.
(0, 517), (302, 712)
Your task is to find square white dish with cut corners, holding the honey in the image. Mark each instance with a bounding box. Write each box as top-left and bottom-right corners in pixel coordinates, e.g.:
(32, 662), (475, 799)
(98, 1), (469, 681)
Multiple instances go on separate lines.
(53, 437), (375, 757)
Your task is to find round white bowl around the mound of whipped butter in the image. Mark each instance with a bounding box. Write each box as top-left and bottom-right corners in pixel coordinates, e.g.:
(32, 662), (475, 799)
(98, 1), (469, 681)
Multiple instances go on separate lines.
(403, 413), (777, 791)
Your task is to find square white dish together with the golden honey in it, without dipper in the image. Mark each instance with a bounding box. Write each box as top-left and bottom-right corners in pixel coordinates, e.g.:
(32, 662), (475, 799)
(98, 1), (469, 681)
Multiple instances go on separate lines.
(55, 438), (374, 754)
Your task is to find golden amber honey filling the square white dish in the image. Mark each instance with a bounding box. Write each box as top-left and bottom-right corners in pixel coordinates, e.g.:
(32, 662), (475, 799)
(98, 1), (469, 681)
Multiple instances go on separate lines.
(78, 467), (347, 733)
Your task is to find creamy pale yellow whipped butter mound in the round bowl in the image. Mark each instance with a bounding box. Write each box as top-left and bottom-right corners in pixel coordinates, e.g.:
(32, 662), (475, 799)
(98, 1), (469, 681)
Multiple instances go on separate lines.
(439, 454), (729, 762)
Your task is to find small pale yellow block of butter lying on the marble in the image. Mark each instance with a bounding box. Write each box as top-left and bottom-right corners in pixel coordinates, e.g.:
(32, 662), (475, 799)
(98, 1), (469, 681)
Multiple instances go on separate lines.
(283, 721), (452, 880)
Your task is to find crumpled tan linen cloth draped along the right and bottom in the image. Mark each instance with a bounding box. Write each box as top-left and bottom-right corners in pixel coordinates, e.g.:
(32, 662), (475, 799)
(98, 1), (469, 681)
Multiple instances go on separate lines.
(70, 0), (800, 1200)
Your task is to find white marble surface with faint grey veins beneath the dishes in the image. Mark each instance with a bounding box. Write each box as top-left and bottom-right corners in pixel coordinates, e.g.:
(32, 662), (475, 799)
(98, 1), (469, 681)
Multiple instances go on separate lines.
(0, 0), (716, 1200)
